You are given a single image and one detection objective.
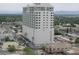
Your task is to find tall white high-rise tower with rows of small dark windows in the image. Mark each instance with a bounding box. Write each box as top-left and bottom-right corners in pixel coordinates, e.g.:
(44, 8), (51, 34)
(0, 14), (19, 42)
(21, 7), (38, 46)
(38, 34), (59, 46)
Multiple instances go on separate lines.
(23, 3), (54, 45)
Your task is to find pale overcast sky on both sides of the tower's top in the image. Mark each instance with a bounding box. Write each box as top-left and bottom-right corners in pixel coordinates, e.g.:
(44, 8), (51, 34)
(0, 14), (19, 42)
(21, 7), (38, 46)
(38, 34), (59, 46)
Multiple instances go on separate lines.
(0, 3), (79, 14)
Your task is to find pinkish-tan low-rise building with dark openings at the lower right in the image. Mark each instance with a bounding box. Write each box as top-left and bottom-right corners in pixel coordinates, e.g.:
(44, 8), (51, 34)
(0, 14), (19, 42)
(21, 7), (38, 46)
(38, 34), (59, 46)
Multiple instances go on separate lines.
(46, 42), (72, 53)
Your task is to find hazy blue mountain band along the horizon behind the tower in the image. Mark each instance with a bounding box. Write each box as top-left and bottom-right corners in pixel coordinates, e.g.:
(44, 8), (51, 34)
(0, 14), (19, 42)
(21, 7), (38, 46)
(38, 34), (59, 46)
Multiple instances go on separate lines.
(0, 11), (79, 16)
